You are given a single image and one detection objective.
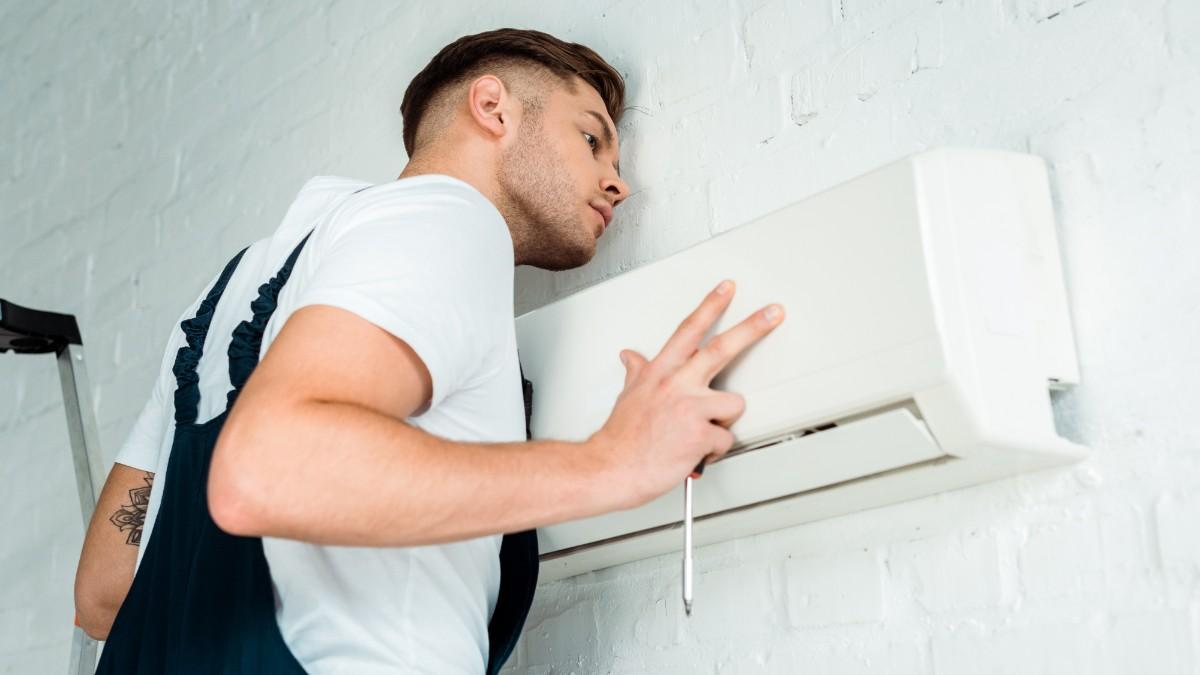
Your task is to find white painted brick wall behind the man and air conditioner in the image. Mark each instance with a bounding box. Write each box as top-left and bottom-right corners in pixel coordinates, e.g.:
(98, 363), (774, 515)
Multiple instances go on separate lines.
(0, 0), (1200, 675)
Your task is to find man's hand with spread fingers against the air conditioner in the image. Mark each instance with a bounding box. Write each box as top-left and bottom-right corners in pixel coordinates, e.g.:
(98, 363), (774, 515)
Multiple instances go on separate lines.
(586, 281), (784, 508)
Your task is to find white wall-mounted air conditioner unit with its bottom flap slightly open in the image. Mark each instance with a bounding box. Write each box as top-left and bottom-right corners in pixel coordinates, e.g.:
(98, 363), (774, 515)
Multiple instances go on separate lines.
(516, 149), (1087, 580)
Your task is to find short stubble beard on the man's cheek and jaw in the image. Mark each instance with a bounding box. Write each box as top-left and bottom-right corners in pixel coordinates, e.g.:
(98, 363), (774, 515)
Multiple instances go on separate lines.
(497, 119), (595, 271)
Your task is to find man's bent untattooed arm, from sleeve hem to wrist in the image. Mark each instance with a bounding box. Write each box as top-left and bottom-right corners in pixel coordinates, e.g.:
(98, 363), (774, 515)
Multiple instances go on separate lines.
(208, 305), (618, 546)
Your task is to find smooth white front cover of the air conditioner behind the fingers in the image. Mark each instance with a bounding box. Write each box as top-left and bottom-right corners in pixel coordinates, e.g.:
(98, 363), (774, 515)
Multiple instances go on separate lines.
(517, 157), (944, 442)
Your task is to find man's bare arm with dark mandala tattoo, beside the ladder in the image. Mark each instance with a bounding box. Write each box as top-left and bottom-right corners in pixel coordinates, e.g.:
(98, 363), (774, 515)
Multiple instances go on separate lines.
(74, 464), (154, 640)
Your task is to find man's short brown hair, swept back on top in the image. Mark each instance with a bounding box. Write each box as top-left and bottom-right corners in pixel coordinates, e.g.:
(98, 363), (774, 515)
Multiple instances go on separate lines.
(400, 28), (625, 157)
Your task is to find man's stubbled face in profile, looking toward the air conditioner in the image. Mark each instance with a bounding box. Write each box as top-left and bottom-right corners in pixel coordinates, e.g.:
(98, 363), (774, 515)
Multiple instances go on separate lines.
(497, 80), (629, 270)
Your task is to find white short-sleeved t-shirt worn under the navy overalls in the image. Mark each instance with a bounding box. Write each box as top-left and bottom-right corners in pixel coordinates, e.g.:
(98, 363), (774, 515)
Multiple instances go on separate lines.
(116, 174), (526, 675)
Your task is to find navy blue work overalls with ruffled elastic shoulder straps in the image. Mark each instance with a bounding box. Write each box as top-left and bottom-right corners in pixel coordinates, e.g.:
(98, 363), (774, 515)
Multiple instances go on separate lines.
(96, 228), (538, 675)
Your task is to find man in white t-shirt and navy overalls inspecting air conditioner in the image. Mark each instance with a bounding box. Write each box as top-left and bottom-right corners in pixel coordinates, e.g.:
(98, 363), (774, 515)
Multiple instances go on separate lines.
(76, 29), (781, 674)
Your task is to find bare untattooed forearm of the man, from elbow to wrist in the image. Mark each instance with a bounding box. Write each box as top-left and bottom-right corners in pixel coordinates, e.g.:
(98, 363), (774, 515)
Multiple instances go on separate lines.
(209, 401), (616, 546)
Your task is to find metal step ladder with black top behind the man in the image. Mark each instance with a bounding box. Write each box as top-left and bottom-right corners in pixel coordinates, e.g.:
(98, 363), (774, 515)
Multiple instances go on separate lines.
(0, 298), (104, 675)
